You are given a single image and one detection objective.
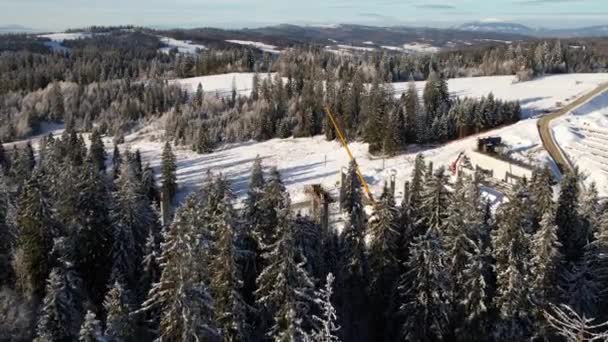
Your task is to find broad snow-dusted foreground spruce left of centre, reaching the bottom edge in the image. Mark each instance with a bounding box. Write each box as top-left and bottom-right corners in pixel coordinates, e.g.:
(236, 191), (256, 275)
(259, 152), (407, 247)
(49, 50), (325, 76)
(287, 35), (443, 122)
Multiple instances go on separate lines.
(138, 196), (217, 341)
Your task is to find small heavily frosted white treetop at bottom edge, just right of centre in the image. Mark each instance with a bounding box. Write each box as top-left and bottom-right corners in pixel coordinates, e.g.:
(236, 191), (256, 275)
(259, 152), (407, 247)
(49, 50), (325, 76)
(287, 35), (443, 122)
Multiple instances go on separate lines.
(312, 273), (340, 342)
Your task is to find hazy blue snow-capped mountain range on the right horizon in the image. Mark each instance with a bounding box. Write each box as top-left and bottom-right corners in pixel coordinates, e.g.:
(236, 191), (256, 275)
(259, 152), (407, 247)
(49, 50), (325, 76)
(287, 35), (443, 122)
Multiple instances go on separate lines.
(454, 22), (608, 38)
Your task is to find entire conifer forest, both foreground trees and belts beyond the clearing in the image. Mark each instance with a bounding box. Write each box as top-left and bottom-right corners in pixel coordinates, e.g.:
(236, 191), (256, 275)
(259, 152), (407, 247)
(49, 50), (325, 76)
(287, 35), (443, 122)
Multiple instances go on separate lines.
(0, 27), (608, 342)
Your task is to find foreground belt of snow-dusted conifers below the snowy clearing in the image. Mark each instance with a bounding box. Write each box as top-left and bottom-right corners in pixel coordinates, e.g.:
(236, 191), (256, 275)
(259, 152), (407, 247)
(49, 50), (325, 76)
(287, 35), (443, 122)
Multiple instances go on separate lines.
(0, 130), (608, 341)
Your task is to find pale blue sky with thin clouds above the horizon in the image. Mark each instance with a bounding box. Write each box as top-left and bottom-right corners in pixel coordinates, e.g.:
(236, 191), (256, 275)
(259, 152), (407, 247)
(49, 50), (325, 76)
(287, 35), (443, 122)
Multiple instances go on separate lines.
(0, 0), (608, 30)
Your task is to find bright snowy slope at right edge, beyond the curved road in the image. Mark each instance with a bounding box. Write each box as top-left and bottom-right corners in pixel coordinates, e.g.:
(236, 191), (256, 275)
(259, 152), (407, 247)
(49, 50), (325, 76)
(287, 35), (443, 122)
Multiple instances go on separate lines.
(551, 92), (608, 196)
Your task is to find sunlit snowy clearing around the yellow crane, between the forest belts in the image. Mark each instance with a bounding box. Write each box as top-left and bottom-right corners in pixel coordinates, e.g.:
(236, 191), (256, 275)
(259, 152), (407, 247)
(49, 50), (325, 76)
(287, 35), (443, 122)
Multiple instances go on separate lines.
(116, 115), (548, 208)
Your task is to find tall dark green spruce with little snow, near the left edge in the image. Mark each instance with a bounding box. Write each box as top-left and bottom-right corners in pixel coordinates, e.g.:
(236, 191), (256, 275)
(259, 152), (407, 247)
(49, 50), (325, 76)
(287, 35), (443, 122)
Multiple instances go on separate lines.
(17, 177), (55, 296)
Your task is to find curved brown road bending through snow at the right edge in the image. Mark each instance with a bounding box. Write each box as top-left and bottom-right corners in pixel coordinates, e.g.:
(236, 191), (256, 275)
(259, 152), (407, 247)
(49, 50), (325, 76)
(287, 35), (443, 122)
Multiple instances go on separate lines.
(537, 83), (608, 174)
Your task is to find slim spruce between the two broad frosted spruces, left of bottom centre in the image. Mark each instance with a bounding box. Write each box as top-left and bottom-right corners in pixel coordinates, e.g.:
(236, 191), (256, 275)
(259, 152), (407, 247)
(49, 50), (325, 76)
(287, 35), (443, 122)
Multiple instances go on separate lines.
(210, 196), (249, 341)
